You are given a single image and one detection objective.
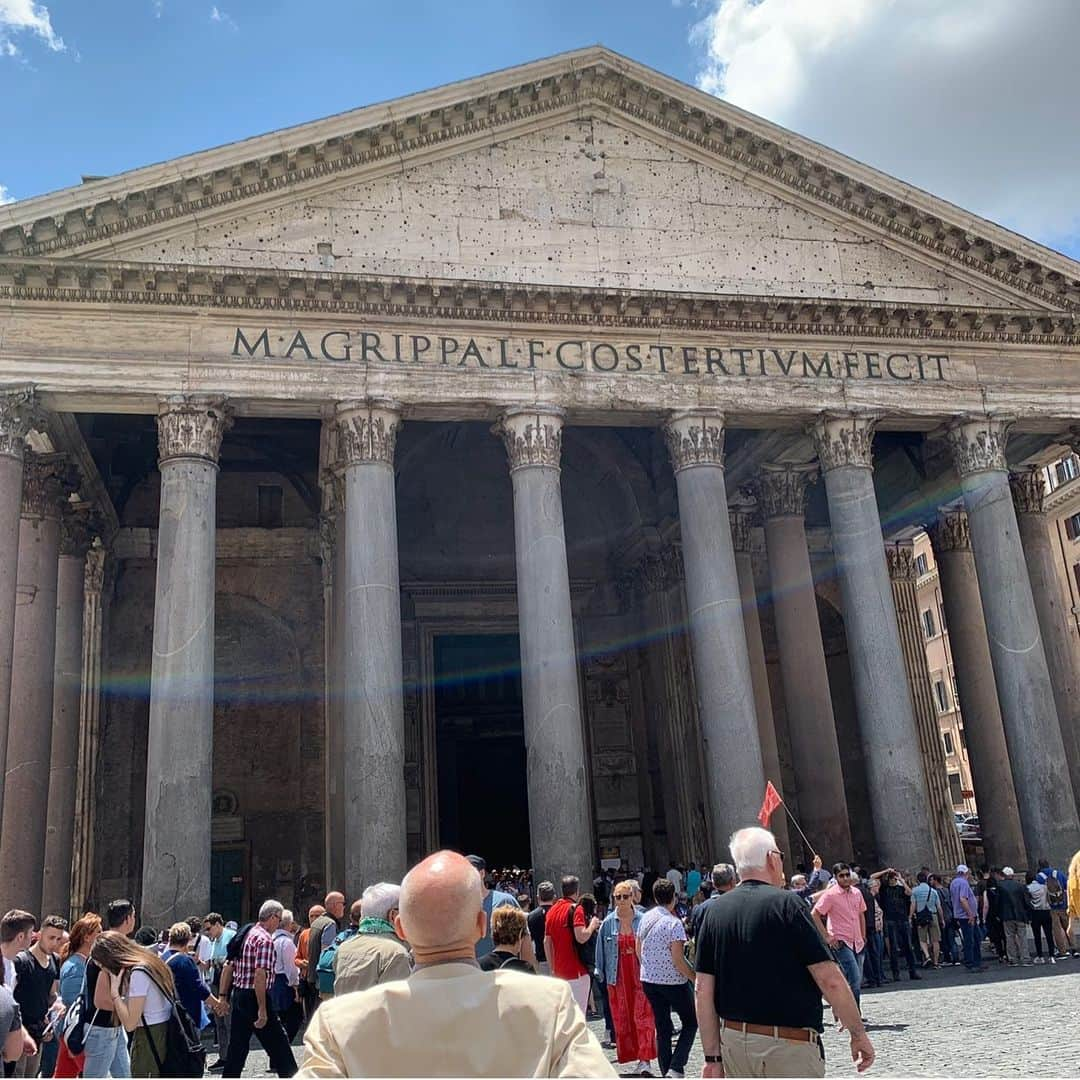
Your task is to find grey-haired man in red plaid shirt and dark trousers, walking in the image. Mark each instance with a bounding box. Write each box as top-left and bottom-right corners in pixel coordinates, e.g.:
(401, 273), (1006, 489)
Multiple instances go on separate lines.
(221, 900), (296, 1077)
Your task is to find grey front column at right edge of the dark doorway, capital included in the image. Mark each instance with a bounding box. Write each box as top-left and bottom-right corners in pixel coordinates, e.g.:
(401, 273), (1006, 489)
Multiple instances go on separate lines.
(496, 406), (596, 881)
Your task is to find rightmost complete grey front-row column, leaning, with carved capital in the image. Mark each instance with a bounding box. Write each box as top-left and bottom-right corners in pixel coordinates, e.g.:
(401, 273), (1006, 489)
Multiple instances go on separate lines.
(948, 417), (1080, 865)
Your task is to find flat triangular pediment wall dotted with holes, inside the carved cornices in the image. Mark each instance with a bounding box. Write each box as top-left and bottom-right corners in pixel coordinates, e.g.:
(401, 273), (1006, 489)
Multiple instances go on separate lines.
(95, 116), (1036, 307)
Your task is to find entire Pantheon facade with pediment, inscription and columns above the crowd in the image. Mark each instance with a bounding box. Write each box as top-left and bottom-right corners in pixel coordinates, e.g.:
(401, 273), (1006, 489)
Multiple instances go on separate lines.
(0, 48), (1080, 928)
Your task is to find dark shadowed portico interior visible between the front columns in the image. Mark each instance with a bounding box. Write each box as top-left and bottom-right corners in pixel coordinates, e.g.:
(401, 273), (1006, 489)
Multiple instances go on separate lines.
(79, 415), (1028, 915)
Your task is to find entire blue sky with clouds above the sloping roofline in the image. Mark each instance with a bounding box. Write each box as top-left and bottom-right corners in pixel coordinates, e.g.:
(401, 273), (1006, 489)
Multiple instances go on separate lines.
(0, 0), (1080, 257)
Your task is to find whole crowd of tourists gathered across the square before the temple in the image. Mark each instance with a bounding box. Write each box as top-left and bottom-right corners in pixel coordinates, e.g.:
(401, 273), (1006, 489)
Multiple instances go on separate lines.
(0, 846), (1080, 1077)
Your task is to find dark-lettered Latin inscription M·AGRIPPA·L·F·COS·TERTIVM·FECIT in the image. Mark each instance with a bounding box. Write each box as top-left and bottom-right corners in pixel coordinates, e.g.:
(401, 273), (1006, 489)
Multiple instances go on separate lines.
(231, 326), (948, 382)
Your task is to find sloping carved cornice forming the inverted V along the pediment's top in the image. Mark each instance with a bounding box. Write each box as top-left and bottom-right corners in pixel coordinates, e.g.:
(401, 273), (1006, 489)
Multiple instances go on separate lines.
(0, 46), (1080, 308)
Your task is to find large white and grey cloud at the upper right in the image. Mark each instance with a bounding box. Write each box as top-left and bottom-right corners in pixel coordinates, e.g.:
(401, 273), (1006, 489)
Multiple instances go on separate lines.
(691, 0), (1080, 254)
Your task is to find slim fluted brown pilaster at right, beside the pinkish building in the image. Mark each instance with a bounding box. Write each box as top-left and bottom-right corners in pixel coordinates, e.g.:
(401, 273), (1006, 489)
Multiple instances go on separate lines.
(886, 540), (963, 866)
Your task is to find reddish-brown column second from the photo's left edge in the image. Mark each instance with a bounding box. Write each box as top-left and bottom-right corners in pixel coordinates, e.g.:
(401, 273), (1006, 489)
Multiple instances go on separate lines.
(0, 454), (66, 914)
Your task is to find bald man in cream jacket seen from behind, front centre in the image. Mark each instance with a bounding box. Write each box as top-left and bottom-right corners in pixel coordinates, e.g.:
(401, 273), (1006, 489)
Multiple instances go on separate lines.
(297, 851), (616, 1077)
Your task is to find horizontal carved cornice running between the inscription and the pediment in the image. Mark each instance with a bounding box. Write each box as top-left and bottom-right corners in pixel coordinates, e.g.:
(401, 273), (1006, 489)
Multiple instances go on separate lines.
(0, 257), (1080, 346)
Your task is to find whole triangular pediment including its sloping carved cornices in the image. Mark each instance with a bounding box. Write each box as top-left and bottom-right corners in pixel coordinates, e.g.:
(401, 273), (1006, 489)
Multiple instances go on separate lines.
(0, 48), (1080, 311)
